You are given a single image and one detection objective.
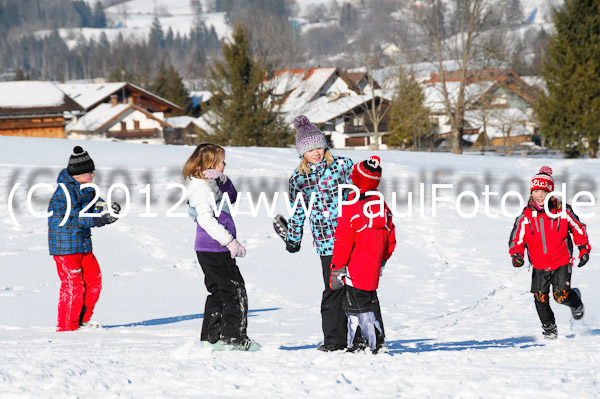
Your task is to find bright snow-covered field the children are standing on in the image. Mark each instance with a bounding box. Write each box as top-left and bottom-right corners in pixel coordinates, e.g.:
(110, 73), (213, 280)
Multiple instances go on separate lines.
(0, 137), (600, 399)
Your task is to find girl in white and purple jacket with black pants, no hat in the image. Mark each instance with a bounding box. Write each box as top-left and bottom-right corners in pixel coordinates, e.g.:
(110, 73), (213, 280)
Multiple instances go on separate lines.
(183, 143), (260, 351)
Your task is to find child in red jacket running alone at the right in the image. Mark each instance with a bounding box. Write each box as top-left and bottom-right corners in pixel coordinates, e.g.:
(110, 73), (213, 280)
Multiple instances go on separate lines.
(509, 166), (591, 338)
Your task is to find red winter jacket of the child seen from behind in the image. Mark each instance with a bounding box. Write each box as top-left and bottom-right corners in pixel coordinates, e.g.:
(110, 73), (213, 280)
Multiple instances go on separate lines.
(331, 195), (396, 291)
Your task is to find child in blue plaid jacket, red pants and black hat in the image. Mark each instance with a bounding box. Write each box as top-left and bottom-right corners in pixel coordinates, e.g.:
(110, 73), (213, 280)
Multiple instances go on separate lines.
(48, 146), (121, 331)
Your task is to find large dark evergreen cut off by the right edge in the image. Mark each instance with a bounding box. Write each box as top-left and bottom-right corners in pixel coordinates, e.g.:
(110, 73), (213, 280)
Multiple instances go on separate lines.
(537, 0), (600, 158)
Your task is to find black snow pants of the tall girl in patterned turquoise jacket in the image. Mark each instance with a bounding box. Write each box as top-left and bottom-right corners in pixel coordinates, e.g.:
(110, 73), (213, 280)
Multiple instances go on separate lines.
(321, 256), (348, 346)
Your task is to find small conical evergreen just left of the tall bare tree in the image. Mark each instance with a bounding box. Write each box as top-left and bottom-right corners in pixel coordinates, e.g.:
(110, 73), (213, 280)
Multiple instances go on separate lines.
(388, 71), (434, 149)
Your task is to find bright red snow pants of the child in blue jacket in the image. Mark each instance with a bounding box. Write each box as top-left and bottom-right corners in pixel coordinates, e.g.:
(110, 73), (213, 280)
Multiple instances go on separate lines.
(54, 252), (102, 331)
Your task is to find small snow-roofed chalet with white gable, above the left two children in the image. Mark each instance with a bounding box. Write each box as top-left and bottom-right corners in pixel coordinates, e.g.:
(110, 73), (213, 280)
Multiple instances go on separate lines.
(66, 98), (172, 144)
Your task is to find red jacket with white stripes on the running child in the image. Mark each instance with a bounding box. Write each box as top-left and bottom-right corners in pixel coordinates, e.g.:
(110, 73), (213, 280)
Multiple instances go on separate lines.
(509, 199), (590, 270)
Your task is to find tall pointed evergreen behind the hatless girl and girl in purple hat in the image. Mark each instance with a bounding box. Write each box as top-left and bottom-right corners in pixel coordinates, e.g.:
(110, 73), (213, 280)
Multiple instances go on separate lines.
(207, 23), (289, 146)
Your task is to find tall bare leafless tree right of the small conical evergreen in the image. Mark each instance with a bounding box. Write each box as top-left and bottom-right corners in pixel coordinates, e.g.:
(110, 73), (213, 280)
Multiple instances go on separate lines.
(400, 0), (507, 154)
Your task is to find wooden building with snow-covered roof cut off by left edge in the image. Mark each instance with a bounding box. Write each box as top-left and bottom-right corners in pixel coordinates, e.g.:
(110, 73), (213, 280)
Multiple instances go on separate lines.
(0, 81), (83, 139)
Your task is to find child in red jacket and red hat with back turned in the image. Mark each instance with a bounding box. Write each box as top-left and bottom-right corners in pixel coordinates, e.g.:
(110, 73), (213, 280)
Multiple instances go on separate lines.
(329, 156), (396, 353)
